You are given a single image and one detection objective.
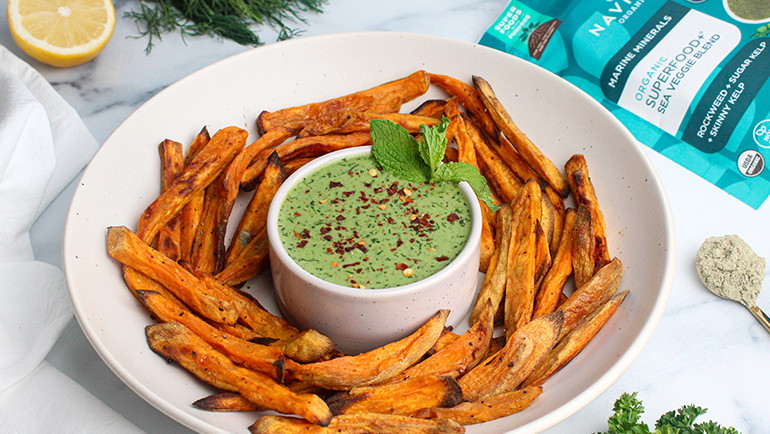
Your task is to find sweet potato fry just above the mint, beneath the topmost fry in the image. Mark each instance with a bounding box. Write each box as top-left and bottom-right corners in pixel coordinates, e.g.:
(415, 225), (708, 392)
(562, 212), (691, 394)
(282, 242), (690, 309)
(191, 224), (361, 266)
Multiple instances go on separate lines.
(298, 111), (439, 137)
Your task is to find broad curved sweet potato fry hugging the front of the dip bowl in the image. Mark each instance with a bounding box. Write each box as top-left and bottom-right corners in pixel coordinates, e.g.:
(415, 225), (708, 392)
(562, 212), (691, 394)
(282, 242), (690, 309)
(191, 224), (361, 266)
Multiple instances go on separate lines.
(287, 309), (449, 390)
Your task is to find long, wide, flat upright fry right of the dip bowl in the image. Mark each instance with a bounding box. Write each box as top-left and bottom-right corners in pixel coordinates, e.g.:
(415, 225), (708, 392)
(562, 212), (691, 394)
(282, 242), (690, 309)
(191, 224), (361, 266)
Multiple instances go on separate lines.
(503, 180), (541, 336)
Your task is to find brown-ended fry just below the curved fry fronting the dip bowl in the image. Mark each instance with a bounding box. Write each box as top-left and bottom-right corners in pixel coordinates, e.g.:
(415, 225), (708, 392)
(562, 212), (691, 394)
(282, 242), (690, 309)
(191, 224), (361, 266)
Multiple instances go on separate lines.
(327, 375), (462, 416)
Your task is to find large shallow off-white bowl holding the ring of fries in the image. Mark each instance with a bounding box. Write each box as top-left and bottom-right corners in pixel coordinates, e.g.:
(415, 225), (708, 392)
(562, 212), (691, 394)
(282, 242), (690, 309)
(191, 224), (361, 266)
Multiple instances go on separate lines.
(63, 32), (675, 434)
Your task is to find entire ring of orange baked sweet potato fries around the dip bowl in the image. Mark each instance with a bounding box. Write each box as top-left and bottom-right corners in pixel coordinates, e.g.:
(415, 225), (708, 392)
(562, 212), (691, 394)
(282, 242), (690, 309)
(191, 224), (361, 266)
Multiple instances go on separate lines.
(107, 71), (628, 433)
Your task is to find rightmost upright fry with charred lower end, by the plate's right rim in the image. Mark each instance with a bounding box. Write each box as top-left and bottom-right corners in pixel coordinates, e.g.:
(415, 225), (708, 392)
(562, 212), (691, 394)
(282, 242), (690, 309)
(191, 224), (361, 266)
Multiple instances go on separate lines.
(564, 154), (611, 272)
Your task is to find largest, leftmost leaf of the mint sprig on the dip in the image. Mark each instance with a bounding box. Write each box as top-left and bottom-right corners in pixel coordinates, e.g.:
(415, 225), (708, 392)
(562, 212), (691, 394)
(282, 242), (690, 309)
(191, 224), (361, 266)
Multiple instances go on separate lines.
(369, 119), (430, 182)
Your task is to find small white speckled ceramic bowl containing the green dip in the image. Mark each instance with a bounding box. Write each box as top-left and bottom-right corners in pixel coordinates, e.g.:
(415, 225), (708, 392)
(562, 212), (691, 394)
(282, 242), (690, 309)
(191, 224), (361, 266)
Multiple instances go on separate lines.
(267, 146), (481, 354)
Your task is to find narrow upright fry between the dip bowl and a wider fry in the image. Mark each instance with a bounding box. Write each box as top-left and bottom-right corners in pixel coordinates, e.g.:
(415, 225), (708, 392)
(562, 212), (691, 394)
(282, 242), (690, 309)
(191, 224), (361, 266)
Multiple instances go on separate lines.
(470, 204), (513, 324)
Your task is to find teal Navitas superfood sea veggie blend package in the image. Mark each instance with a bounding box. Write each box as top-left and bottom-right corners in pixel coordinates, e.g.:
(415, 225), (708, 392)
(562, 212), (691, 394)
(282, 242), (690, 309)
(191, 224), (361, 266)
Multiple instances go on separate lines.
(480, 0), (770, 209)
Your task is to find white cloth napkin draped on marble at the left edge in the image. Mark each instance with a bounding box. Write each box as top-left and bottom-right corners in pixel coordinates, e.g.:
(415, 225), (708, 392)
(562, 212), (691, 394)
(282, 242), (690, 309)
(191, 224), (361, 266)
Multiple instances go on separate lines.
(0, 46), (137, 433)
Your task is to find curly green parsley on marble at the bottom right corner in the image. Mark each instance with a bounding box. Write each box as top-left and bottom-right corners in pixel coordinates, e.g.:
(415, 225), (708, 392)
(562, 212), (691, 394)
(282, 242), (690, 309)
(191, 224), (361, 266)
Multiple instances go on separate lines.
(606, 392), (738, 434)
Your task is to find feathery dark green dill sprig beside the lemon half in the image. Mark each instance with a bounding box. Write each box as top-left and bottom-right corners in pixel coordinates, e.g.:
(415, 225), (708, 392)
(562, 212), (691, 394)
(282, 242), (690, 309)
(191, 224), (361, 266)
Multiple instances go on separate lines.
(123, 0), (326, 53)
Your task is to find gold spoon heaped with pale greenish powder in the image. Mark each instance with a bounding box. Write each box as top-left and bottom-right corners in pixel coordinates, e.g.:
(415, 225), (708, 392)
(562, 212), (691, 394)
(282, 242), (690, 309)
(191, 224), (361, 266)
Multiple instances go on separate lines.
(695, 235), (770, 332)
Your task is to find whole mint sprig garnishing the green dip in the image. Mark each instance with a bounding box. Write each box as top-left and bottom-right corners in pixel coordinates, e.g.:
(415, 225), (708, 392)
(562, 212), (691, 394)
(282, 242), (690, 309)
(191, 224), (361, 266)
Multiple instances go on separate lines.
(369, 117), (498, 211)
